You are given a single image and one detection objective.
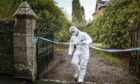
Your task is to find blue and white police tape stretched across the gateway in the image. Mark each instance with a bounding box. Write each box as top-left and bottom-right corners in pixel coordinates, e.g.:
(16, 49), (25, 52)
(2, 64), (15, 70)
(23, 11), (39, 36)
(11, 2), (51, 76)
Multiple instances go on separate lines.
(34, 37), (140, 52)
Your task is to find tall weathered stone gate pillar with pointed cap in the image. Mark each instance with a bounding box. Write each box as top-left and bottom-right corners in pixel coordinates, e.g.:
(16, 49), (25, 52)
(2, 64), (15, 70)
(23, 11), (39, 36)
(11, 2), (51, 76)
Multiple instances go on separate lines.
(14, 1), (36, 81)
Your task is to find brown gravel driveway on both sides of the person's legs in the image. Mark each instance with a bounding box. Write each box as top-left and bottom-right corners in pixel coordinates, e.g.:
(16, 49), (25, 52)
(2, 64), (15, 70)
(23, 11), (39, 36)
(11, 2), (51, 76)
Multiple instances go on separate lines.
(44, 48), (140, 84)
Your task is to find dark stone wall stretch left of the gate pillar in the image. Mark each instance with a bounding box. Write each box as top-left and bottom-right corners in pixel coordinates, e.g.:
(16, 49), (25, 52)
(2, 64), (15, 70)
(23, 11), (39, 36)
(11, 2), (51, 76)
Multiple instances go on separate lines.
(0, 19), (14, 74)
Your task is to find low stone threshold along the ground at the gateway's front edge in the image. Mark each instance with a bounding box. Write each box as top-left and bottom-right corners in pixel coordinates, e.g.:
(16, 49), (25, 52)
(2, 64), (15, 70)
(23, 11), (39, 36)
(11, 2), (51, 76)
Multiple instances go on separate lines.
(37, 79), (96, 84)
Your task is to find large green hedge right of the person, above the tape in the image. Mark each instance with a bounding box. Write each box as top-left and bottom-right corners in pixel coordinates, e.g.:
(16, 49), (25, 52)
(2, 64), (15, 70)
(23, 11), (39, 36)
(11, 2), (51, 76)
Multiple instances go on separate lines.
(86, 0), (140, 48)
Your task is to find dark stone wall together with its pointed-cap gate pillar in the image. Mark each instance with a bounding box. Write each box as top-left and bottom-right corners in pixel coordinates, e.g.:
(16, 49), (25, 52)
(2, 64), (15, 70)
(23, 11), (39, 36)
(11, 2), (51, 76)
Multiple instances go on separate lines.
(0, 1), (37, 81)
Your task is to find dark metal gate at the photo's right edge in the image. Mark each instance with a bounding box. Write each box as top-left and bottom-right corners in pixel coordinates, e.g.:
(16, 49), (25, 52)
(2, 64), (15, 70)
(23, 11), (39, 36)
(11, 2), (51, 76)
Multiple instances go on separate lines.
(129, 24), (140, 74)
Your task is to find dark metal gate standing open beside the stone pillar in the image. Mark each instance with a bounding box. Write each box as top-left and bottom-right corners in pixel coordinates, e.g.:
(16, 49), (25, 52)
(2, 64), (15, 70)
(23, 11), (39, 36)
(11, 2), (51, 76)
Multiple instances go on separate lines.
(35, 28), (53, 79)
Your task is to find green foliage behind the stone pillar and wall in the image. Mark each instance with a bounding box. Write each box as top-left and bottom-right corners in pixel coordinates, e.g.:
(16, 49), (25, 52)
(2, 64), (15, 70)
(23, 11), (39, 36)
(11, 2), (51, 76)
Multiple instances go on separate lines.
(0, 0), (71, 40)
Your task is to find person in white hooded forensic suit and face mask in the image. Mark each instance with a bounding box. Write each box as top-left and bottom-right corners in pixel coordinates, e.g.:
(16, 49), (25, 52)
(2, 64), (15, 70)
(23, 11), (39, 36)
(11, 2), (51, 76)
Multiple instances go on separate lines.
(68, 26), (92, 84)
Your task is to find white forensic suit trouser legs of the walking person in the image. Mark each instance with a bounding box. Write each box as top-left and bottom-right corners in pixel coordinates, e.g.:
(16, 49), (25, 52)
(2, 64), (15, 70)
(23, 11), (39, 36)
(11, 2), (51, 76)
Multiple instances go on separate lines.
(71, 51), (89, 82)
